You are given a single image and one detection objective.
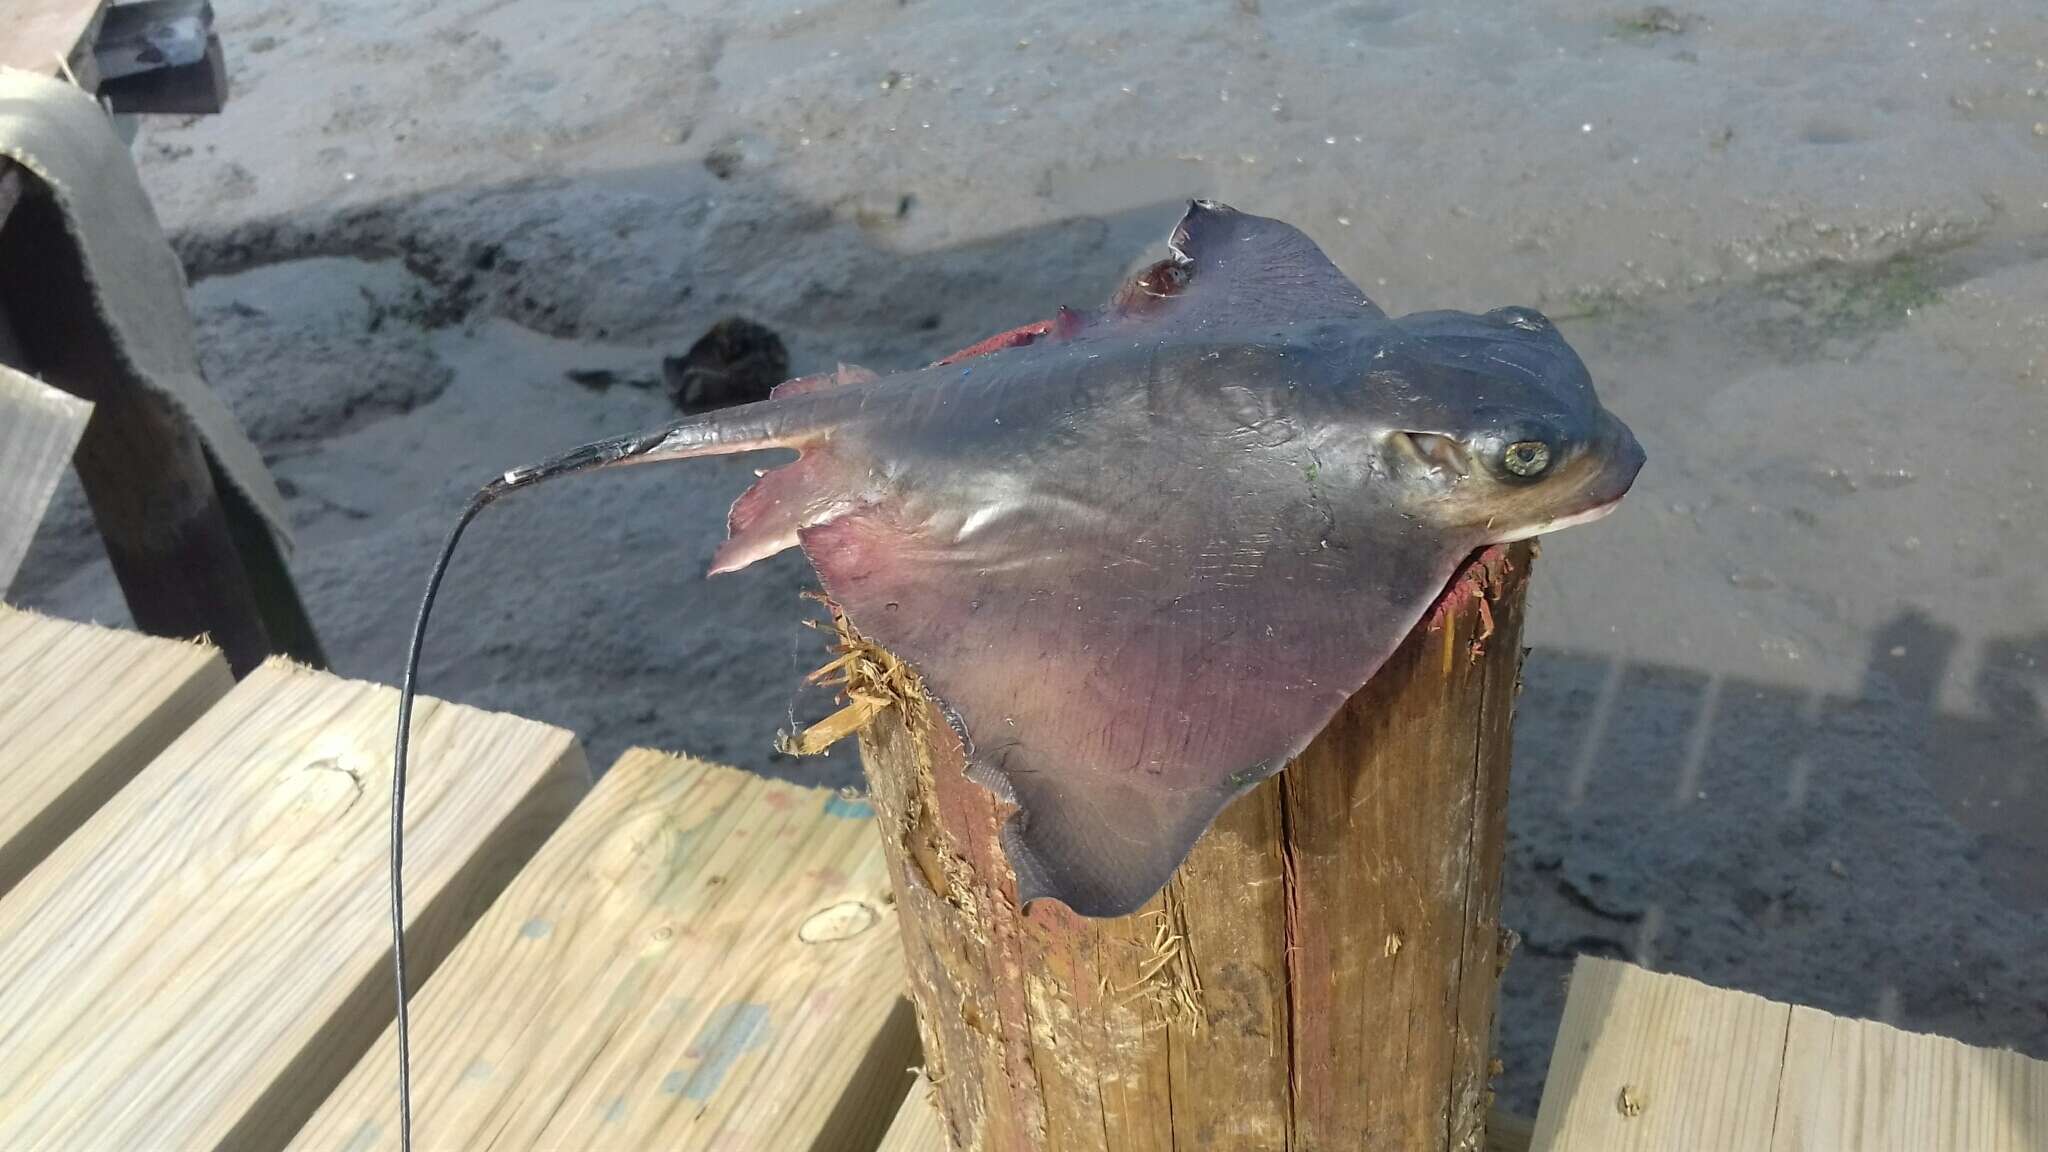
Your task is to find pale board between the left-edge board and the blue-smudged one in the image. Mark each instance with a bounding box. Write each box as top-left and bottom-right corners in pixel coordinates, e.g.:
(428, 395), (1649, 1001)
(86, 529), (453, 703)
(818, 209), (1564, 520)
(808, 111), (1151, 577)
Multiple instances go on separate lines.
(0, 660), (588, 1152)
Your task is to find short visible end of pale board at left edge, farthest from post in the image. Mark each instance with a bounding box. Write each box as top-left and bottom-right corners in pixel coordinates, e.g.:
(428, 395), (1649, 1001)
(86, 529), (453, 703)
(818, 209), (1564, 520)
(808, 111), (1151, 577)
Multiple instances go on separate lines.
(0, 605), (233, 894)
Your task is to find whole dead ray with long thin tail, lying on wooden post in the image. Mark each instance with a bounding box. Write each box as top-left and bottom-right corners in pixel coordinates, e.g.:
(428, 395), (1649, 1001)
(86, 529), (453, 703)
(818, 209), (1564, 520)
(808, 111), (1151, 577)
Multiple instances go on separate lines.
(391, 201), (1642, 1139)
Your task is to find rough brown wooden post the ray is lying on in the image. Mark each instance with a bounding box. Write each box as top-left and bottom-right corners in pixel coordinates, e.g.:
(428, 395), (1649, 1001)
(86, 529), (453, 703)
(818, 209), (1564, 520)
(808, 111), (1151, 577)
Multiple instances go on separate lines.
(854, 543), (1534, 1152)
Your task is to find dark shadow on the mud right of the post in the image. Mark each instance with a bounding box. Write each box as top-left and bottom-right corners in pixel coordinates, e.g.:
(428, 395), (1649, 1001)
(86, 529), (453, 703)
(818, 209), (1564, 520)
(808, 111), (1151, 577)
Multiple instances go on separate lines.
(1503, 611), (2048, 1115)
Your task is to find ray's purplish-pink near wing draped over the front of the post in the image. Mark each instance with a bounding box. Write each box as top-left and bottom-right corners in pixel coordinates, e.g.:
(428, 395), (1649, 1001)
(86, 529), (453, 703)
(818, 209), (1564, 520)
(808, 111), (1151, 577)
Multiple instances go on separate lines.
(801, 358), (1464, 916)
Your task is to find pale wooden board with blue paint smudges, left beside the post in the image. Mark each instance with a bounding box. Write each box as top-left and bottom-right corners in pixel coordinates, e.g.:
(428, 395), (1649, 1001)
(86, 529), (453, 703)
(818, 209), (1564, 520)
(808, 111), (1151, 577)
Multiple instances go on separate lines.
(293, 750), (918, 1152)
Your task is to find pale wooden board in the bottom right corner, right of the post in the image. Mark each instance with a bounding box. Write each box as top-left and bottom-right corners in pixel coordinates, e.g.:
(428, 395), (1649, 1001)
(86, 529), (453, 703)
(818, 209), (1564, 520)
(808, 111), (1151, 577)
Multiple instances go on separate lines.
(1532, 957), (2048, 1152)
